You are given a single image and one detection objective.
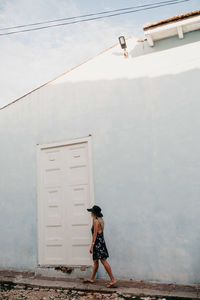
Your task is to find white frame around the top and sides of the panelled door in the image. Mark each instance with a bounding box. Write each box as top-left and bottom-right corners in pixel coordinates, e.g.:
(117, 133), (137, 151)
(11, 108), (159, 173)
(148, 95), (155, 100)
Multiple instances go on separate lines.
(36, 135), (95, 266)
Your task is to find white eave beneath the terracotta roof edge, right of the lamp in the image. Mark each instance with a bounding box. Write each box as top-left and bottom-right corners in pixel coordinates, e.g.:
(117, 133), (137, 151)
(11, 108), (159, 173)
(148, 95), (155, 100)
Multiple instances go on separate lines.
(144, 15), (200, 46)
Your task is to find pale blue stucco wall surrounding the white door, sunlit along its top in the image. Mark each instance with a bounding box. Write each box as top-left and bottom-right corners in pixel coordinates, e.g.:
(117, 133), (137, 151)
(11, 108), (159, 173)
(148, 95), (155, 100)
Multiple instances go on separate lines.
(0, 32), (200, 283)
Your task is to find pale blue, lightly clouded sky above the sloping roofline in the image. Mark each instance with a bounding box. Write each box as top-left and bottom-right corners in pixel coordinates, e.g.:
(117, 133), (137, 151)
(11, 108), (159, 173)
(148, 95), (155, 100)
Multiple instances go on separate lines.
(0, 0), (200, 107)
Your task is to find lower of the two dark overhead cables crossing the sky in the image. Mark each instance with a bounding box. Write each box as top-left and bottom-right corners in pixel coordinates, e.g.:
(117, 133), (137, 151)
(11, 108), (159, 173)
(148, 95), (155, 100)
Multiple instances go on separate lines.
(0, 0), (191, 36)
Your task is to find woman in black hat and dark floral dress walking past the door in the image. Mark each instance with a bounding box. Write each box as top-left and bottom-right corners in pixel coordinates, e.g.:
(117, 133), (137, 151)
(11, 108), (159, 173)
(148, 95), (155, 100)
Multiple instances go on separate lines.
(83, 205), (117, 287)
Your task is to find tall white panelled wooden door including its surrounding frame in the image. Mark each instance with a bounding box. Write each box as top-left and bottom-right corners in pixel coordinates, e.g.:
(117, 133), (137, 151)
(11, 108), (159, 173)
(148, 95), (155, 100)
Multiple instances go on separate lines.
(38, 138), (94, 265)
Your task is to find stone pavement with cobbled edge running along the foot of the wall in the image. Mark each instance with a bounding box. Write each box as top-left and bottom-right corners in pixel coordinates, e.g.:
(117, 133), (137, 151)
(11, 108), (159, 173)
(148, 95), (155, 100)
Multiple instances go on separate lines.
(0, 270), (200, 300)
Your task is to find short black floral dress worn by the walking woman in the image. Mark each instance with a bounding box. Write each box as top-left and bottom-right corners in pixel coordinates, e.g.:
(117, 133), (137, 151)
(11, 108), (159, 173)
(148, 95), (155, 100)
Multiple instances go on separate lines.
(91, 226), (109, 260)
